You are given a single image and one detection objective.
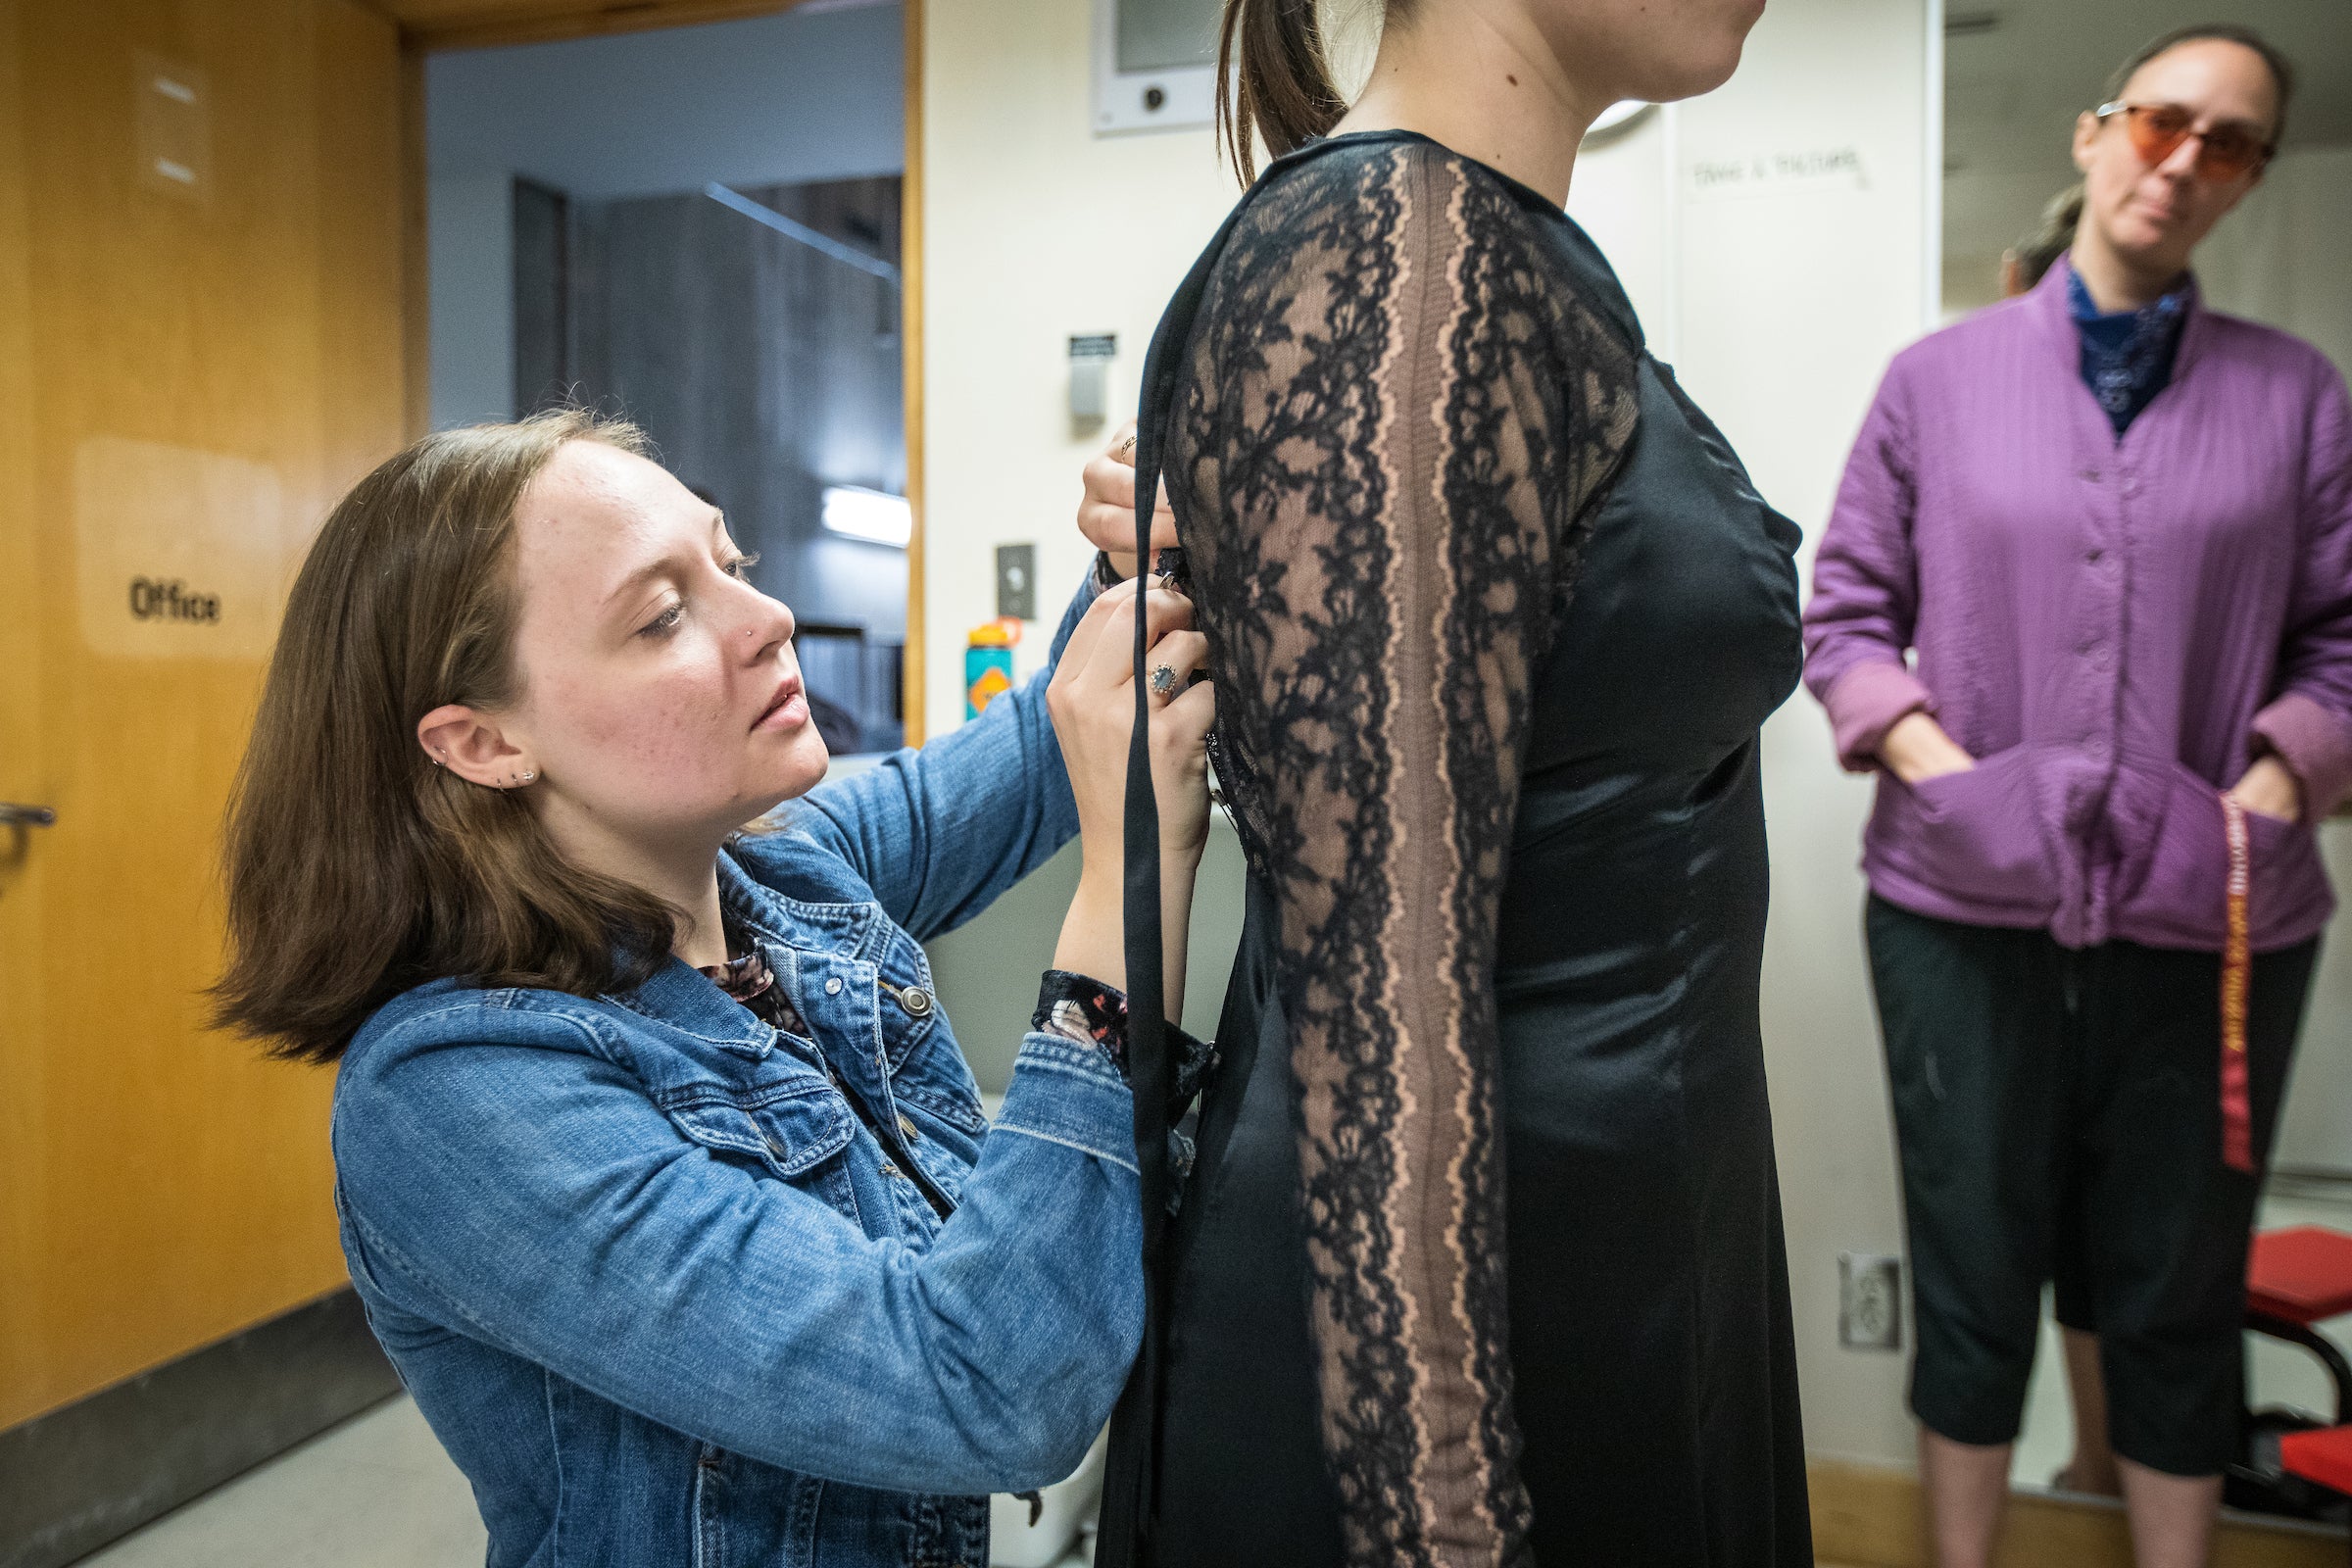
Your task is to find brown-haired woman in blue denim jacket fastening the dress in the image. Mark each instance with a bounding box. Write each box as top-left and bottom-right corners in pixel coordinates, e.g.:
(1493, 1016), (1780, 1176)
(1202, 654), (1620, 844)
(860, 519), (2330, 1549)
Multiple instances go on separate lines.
(221, 412), (1211, 1568)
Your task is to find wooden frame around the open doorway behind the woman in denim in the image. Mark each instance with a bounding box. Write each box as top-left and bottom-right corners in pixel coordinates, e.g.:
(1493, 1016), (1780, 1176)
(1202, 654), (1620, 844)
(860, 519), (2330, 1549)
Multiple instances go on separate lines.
(383, 0), (924, 745)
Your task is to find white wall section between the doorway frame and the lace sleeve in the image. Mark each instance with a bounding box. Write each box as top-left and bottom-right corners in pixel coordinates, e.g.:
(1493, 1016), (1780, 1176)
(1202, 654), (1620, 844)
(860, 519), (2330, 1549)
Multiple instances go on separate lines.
(922, 0), (1237, 733)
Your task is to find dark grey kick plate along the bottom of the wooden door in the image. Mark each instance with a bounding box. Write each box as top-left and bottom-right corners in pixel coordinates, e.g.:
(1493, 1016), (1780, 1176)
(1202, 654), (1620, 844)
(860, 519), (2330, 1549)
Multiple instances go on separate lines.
(0, 1289), (400, 1568)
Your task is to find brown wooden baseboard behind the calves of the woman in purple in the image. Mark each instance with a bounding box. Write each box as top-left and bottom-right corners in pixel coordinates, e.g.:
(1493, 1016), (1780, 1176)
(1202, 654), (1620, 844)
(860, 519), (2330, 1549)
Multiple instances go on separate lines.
(1804, 1460), (2345, 1568)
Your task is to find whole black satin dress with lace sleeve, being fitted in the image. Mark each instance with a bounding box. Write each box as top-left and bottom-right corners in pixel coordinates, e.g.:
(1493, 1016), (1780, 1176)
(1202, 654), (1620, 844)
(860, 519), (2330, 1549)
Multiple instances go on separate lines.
(1101, 131), (1813, 1568)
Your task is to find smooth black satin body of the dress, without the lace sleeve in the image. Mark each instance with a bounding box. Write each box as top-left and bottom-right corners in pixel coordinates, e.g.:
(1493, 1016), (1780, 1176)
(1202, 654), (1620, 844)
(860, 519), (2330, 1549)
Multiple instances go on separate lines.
(1112, 137), (1813, 1568)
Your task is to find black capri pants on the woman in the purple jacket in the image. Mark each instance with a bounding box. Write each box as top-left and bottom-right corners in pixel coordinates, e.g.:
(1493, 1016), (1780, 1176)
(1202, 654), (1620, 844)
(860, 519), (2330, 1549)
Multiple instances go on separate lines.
(1863, 898), (2319, 1476)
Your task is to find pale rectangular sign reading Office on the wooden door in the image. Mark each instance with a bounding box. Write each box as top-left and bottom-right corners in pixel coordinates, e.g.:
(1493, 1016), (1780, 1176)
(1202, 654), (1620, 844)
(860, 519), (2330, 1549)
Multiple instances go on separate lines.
(73, 435), (286, 659)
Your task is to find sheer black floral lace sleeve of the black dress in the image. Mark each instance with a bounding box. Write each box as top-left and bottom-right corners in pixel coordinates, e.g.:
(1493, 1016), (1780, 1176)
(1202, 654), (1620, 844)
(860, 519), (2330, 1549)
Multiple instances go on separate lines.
(1169, 143), (1635, 1568)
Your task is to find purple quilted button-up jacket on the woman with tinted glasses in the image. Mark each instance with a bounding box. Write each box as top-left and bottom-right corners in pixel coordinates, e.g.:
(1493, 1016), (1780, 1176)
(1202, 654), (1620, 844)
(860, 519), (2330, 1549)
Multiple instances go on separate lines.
(1804, 261), (2352, 950)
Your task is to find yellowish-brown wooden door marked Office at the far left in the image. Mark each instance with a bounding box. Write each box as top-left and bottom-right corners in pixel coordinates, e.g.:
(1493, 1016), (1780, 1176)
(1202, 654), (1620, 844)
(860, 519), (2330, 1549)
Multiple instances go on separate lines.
(0, 0), (405, 1427)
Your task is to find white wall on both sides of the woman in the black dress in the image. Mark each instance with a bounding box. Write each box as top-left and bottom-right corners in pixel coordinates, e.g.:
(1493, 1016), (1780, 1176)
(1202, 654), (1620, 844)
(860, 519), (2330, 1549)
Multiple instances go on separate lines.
(924, 0), (1938, 1462)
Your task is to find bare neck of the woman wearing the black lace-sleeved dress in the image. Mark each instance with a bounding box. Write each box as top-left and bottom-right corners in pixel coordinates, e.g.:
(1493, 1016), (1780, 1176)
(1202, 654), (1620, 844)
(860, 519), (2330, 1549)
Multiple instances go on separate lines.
(1336, 7), (1609, 202)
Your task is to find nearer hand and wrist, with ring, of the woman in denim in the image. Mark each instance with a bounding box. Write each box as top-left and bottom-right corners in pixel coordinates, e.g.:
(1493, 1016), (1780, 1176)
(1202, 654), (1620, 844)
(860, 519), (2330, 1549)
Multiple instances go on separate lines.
(1047, 581), (1216, 1018)
